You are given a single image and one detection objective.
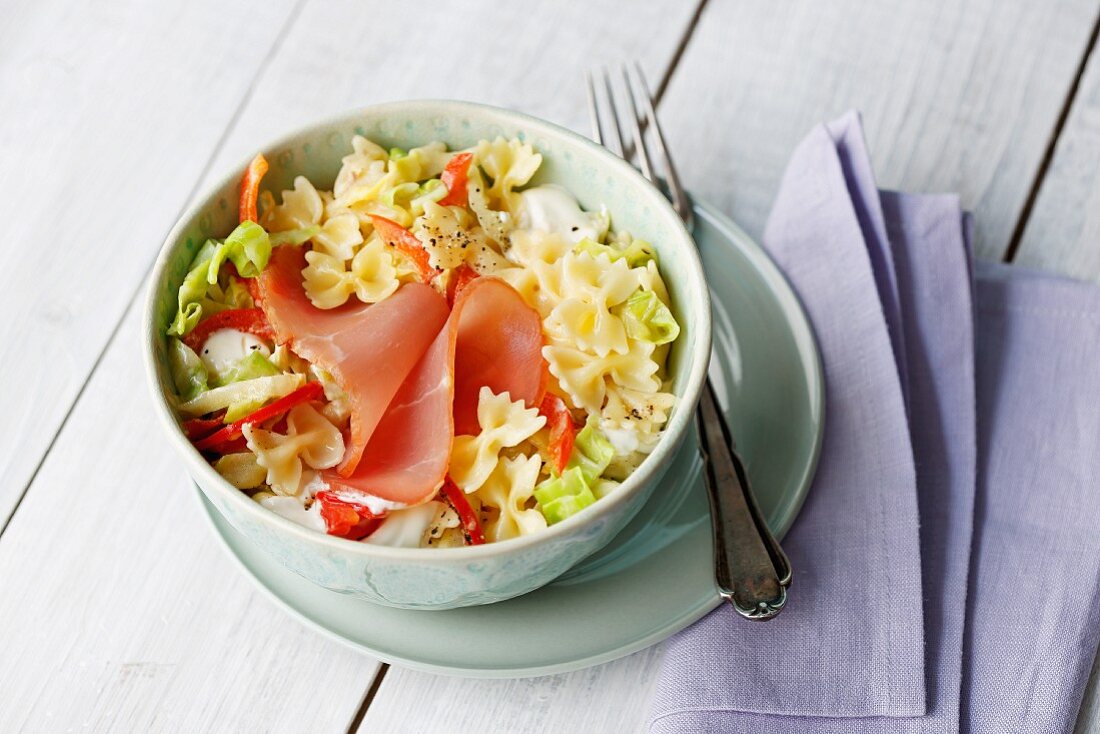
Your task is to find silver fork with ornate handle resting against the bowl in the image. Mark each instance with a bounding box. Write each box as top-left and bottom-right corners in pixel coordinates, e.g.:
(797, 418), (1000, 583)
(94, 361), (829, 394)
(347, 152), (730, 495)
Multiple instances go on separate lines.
(585, 63), (791, 620)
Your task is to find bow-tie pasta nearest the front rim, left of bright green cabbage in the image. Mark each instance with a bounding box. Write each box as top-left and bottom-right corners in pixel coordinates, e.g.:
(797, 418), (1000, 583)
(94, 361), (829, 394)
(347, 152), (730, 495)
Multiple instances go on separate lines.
(476, 454), (547, 543)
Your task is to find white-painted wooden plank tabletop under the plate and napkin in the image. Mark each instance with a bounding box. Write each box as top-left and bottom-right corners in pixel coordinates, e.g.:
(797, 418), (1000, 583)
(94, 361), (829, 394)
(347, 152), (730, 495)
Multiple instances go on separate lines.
(0, 0), (1100, 732)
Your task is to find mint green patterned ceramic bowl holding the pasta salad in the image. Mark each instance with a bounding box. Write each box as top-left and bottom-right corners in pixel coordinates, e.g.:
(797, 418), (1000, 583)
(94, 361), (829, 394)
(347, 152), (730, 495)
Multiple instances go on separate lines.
(142, 101), (711, 610)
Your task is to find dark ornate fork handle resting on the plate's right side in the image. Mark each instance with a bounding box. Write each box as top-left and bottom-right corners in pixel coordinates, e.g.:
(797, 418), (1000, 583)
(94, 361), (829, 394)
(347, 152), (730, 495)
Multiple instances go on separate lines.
(696, 379), (791, 620)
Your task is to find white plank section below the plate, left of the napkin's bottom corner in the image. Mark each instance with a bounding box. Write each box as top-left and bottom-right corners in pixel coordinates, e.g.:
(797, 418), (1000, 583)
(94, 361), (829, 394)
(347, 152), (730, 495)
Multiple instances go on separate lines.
(358, 640), (662, 734)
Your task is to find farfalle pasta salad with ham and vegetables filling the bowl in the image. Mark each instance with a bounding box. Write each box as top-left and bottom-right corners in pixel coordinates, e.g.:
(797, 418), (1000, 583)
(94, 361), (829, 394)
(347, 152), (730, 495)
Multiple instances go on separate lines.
(166, 135), (680, 549)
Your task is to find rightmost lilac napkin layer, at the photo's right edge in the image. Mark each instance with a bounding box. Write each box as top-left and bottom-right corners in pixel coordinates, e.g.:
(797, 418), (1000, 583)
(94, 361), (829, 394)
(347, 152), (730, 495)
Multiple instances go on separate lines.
(963, 264), (1100, 734)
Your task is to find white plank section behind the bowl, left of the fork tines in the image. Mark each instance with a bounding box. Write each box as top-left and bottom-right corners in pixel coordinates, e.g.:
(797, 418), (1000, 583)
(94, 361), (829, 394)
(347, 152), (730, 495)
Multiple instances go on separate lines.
(201, 0), (699, 178)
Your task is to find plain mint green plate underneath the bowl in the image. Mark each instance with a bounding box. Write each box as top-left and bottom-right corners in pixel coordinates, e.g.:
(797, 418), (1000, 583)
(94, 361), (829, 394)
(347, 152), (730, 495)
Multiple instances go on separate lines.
(196, 204), (824, 678)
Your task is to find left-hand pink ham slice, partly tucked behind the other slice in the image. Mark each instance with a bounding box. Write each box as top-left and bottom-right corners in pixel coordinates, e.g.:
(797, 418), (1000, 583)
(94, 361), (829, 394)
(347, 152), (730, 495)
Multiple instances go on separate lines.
(259, 247), (448, 474)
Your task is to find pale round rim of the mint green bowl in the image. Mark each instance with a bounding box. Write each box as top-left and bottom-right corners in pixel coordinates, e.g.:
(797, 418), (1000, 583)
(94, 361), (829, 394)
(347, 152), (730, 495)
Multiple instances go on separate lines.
(142, 99), (711, 563)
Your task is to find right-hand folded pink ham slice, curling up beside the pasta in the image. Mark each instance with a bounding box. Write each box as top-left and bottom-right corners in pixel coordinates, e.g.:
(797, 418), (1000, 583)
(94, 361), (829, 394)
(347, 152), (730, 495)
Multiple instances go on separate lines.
(323, 277), (547, 505)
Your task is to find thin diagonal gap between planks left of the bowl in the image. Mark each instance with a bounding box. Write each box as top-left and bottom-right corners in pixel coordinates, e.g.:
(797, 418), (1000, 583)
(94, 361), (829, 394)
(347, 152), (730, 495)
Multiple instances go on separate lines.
(0, 0), (308, 538)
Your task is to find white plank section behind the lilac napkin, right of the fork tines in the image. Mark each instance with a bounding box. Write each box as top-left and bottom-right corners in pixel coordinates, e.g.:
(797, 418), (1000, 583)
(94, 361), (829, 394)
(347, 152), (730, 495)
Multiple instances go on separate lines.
(663, 0), (1097, 259)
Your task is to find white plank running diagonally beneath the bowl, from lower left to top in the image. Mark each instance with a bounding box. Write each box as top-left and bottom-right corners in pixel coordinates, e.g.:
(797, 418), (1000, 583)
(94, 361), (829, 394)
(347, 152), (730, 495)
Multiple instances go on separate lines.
(0, 0), (692, 731)
